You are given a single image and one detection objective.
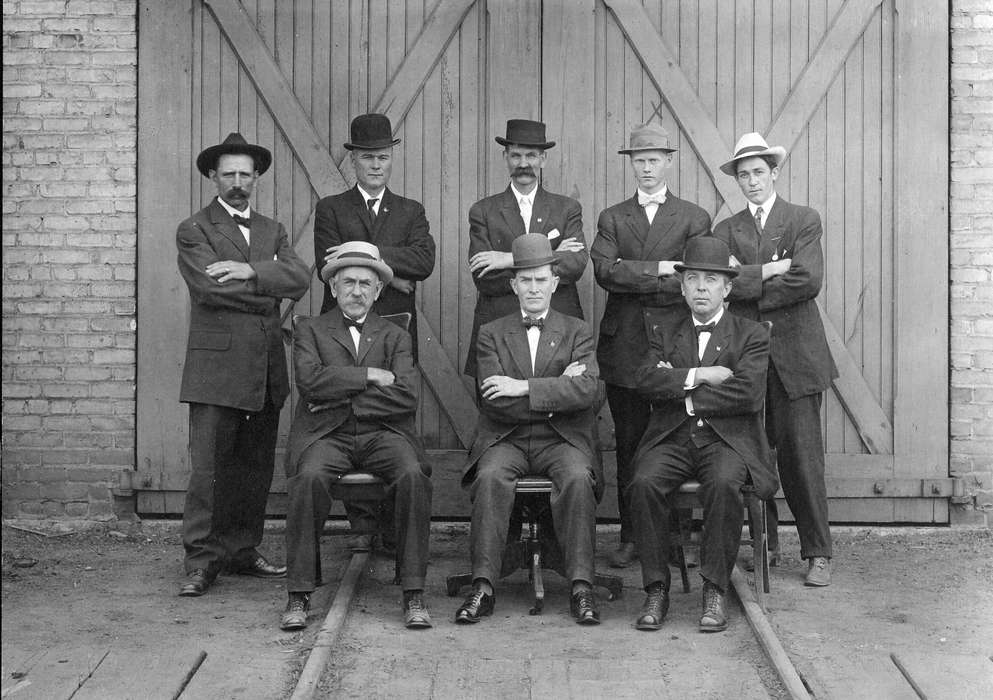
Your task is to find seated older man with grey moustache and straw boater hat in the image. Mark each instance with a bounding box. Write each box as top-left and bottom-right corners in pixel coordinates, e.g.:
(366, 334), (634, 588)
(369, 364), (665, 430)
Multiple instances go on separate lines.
(280, 241), (431, 630)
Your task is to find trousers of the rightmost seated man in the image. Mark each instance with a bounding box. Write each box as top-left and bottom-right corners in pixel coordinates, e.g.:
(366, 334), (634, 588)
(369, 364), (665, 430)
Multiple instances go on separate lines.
(627, 440), (748, 591)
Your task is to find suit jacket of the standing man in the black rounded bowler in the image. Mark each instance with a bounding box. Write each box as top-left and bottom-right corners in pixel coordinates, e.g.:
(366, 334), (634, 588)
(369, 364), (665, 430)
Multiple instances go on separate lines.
(314, 187), (435, 362)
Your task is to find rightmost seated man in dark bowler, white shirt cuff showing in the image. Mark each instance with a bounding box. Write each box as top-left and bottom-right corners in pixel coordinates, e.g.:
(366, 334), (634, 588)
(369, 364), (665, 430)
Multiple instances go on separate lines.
(627, 236), (778, 632)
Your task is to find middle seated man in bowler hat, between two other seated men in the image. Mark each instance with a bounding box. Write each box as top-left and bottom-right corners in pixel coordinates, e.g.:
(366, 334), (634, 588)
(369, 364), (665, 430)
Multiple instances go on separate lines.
(455, 233), (603, 625)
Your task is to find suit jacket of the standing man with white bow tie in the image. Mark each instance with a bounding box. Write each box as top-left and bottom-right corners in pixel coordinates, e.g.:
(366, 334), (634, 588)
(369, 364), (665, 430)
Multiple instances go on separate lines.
(590, 192), (710, 388)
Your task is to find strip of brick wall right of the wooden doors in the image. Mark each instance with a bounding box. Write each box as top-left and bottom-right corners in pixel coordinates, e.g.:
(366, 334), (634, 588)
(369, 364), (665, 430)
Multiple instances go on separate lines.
(949, 0), (993, 526)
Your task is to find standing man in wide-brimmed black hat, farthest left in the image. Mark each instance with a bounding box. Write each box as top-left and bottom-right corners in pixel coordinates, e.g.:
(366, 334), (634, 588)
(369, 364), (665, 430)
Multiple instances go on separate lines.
(176, 133), (309, 596)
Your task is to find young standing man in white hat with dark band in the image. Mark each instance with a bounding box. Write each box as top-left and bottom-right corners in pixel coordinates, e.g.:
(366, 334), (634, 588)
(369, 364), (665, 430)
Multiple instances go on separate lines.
(714, 133), (838, 586)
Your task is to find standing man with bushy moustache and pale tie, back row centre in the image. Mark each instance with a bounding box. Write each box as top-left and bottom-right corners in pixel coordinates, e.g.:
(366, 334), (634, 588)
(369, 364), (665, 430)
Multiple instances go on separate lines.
(465, 119), (589, 377)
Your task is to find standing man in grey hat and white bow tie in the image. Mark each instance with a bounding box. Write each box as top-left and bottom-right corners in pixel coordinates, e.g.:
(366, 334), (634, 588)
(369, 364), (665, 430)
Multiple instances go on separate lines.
(590, 124), (710, 568)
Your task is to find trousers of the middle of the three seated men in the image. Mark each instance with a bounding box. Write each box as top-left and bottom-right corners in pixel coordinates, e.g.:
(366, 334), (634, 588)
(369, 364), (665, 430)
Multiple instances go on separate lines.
(469, 424), (596, 584)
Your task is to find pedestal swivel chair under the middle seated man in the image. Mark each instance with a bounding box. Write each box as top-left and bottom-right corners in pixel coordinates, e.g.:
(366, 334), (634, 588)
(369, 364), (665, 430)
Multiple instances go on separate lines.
(446, 476), (624, 615)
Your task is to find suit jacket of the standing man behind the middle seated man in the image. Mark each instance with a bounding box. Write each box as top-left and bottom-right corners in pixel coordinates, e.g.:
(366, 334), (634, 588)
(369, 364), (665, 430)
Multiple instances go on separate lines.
(465, 185), (589, 376)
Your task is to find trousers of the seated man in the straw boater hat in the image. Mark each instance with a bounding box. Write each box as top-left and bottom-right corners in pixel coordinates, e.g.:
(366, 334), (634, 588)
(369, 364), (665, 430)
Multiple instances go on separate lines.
(286, 427), (432, 593)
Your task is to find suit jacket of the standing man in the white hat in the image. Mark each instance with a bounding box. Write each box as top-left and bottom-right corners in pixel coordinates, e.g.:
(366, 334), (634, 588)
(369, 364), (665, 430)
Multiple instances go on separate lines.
(714, 197), (838, 399)
